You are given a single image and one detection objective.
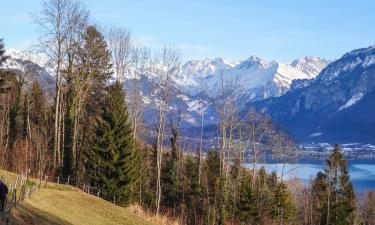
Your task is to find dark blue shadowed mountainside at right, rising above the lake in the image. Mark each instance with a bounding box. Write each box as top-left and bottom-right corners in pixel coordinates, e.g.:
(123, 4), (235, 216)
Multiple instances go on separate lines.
(252, 46), (375, 143)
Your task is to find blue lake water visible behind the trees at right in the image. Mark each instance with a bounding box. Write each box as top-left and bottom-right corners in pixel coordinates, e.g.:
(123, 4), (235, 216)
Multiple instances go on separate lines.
(247, 159), (375, 191)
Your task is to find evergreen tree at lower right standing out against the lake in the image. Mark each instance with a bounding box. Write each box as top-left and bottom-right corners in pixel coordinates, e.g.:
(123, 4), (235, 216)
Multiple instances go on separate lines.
(313, 145), (355, 225)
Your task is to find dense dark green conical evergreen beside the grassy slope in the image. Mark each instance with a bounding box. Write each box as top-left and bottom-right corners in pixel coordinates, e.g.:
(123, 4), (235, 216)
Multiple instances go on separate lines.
(86, 82), (139, 205)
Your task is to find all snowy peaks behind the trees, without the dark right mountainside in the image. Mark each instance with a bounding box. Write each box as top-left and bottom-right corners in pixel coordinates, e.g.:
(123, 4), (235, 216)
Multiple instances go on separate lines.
(2, 50), (329, 134)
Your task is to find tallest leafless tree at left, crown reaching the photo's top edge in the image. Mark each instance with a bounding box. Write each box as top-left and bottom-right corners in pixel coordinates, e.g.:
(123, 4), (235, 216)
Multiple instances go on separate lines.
(34, 0), (88, 166)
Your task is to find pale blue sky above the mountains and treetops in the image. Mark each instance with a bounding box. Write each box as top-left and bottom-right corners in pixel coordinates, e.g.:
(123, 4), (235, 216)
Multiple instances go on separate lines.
(0, 0), (375, 62)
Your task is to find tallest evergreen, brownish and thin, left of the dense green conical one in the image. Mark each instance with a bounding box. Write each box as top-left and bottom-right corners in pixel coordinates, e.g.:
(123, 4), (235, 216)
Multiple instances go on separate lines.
(63, 26), (111, 176)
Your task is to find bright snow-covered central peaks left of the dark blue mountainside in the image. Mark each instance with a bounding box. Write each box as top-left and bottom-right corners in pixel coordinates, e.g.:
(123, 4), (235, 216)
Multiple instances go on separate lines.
(176, 56), (329, 101)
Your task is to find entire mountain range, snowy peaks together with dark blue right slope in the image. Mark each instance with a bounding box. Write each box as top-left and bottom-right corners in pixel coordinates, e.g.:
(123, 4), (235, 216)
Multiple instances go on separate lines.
(3, 47), (375, 143)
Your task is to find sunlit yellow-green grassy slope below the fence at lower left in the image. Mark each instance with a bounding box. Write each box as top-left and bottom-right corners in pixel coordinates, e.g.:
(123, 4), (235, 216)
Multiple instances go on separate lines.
(0, 171), (160, 225)
